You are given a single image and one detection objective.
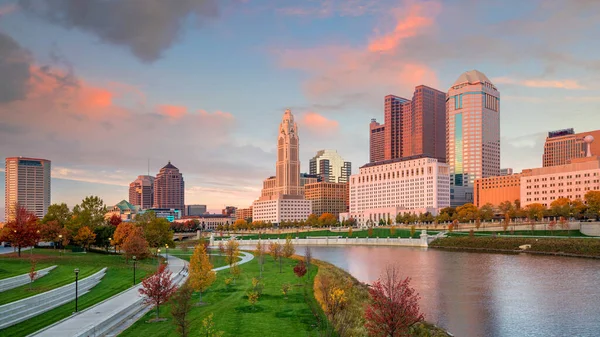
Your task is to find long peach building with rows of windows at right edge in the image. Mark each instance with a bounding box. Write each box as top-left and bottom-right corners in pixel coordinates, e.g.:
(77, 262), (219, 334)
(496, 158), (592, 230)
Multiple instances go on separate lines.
(521, 156), (600, 207)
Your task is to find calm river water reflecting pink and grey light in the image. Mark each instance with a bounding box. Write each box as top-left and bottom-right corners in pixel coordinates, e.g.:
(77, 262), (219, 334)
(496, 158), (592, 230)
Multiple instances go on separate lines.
(297, 246), (600, 337)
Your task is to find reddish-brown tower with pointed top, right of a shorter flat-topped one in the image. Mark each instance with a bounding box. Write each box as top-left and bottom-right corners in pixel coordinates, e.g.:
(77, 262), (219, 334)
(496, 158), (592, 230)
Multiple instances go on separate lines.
(153, 162), (185, 212)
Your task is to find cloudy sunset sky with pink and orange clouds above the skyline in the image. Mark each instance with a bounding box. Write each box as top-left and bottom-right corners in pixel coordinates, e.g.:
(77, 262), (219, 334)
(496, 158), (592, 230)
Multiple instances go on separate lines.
(0, 0), (600, 217)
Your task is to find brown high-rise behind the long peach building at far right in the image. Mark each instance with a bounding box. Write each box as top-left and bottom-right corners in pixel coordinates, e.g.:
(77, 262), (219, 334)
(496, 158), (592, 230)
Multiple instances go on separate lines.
(542, 129), (600, 167)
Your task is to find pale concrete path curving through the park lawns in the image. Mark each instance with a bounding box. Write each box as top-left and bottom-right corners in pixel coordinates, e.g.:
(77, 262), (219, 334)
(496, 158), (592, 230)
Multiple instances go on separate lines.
(31, 252), (254, 337)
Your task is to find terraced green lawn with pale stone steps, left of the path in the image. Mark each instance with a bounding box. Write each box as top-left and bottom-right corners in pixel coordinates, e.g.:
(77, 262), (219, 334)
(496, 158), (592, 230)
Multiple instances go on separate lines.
(0, 249), (156, 336)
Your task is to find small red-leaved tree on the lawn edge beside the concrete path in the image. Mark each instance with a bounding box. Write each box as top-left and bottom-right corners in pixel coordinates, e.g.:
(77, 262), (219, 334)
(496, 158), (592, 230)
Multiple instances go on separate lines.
(139, 264), (177, 320)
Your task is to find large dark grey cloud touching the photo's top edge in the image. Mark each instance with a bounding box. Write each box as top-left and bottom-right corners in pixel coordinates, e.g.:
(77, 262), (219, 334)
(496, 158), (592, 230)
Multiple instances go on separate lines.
(19, 0), (222, 62)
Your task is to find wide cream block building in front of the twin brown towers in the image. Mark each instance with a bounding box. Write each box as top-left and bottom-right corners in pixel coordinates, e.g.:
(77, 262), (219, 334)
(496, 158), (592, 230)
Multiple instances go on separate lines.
(340, 156), (450, 225)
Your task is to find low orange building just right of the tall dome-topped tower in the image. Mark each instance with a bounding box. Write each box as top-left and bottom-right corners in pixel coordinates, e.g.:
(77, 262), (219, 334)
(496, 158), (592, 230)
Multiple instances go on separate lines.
(473, 170), (530, 207)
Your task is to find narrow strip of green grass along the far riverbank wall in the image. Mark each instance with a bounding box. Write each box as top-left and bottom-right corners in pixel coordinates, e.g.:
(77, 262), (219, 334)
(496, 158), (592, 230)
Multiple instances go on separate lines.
(215, 228), (438, 240)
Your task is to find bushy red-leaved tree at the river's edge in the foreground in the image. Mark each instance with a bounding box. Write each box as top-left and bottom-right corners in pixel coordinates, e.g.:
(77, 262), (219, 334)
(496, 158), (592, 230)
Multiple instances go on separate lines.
(365, 267), (424, 337)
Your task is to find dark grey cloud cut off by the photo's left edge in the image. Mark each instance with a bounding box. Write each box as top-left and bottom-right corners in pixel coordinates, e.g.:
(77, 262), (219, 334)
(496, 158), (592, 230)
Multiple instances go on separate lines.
(0, 32), (31, 103)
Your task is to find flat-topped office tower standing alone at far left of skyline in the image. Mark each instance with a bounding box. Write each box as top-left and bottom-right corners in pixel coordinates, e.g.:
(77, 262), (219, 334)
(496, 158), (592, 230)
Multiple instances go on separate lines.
(4, 157), (50, 222)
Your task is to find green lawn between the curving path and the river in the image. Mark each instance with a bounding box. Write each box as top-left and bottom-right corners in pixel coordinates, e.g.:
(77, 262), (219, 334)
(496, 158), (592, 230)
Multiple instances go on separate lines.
(120, 252), (322, 337)
